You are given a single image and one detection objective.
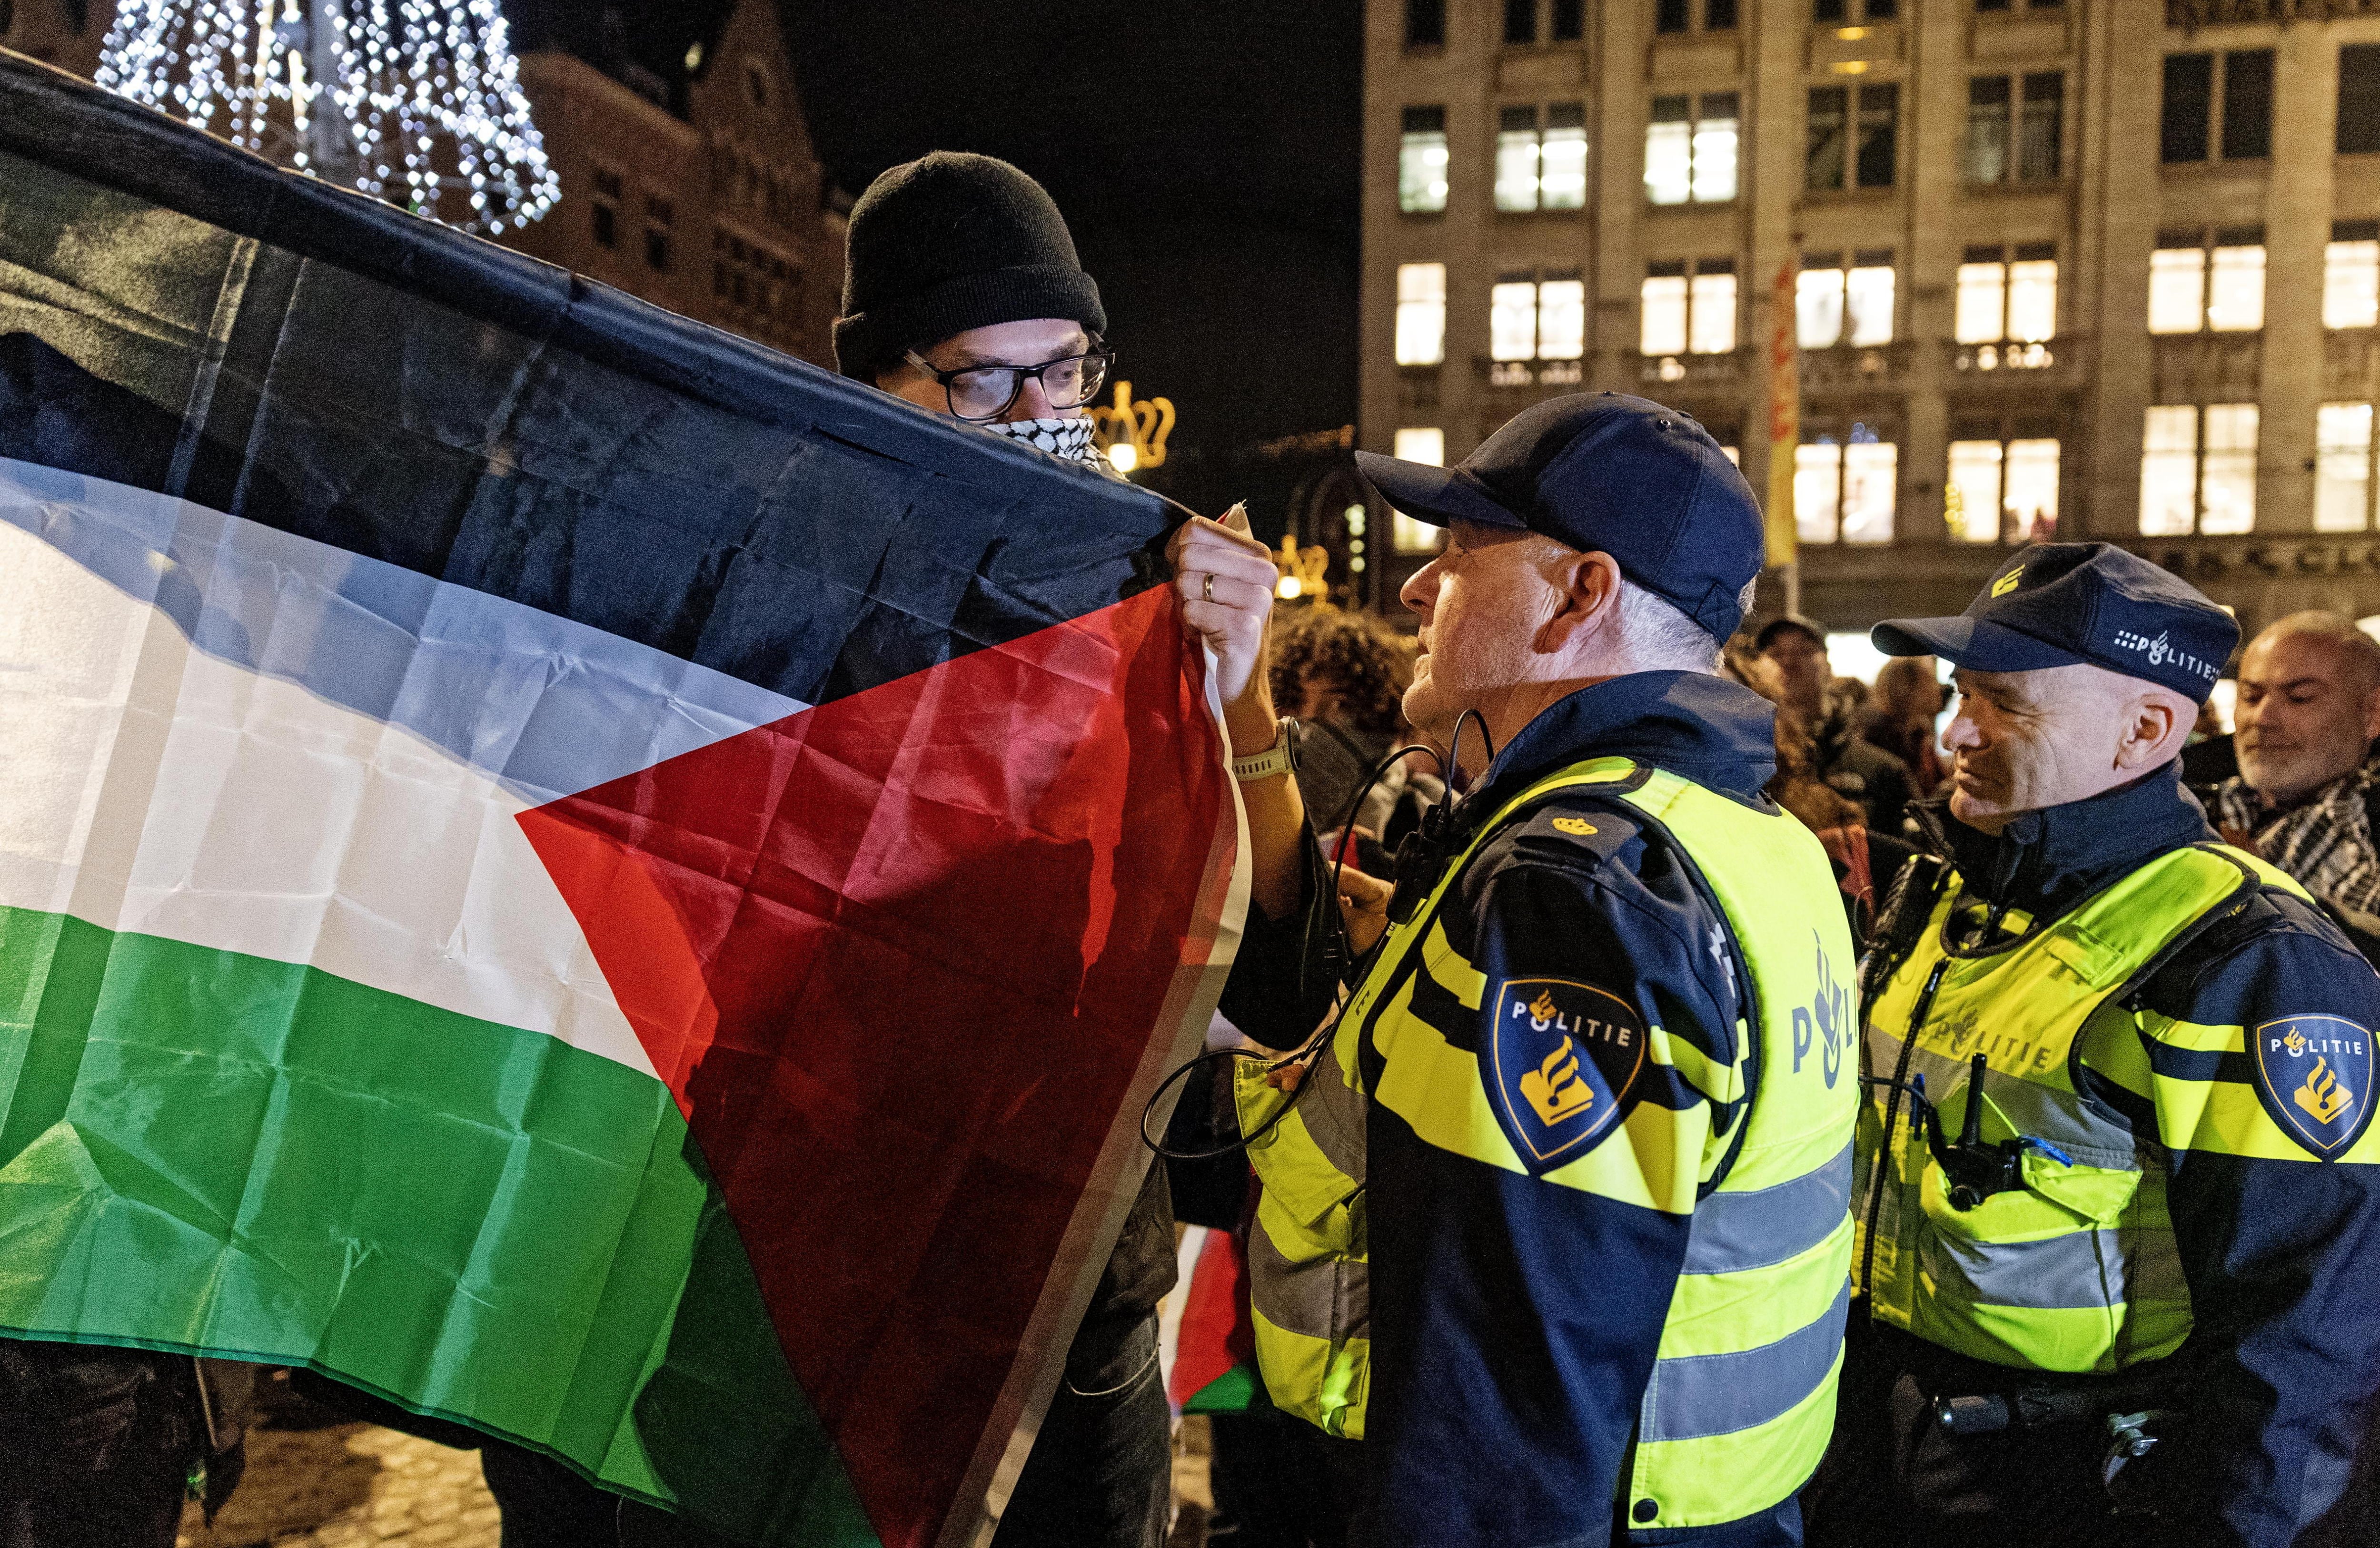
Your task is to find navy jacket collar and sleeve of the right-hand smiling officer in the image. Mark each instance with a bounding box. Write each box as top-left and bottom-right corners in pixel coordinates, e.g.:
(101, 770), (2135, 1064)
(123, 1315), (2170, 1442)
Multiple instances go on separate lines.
(1918, 763), (2380, 1548)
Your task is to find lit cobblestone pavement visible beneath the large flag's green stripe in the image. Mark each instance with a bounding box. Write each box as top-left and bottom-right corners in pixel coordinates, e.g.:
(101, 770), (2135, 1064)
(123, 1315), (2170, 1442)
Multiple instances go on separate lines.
(178, 1424), (500, 1548)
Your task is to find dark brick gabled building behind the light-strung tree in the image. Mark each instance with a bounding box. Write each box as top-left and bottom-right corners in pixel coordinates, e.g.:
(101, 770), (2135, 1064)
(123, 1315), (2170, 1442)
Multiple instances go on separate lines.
(0, 0), (847, 369)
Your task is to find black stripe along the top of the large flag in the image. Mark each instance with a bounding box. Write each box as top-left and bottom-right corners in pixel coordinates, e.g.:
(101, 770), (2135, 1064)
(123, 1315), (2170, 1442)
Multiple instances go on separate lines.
(0, 55), (1173, 704)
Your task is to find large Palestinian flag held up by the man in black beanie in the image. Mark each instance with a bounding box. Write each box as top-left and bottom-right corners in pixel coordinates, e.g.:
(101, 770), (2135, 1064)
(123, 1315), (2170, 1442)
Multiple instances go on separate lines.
(0, 55), (1242, 1548)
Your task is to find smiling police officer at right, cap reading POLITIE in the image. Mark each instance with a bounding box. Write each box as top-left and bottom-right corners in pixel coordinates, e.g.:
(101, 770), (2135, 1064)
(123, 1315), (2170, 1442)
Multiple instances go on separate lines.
(1811, 544), (2380, 1548)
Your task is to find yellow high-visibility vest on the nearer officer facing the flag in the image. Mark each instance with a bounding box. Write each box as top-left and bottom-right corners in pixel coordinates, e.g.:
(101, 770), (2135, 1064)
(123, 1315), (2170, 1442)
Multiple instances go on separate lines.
(1238, 759), (1859, 1529)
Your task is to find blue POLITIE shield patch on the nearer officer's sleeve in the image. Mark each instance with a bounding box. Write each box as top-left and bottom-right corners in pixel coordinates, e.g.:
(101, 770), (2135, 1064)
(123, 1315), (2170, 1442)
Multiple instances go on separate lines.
(1480, 977), (1645, 1172)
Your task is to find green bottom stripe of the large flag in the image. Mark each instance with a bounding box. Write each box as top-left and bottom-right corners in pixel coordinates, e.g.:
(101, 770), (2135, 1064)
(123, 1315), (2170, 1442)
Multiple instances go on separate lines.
(0, 908), (876, 1548)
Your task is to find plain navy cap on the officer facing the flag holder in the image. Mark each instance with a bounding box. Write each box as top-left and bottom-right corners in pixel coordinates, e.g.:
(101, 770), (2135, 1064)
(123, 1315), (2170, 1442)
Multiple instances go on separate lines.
(1354, 392), (1761, 640)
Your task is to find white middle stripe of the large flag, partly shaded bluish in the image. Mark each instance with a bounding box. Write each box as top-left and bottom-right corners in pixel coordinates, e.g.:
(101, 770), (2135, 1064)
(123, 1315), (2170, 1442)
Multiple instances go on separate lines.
(0, 463), (800, 1075)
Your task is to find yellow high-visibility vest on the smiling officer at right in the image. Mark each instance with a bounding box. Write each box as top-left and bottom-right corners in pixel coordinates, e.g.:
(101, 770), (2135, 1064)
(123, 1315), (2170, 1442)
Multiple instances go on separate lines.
(1854, 844), (2299, 1372)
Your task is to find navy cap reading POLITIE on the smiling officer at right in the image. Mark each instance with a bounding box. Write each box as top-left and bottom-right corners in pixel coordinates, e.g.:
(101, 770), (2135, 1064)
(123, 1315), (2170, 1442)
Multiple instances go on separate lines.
(1868, 542), (2240, 704)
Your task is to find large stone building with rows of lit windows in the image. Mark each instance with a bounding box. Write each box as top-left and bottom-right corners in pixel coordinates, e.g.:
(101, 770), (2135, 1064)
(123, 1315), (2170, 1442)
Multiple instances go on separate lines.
(1347, 0), (2380, 630)
